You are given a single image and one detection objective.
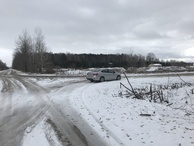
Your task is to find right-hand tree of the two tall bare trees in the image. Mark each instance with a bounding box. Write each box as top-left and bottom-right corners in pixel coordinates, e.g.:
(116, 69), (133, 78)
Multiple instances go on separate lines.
(34, 28), (48, 73)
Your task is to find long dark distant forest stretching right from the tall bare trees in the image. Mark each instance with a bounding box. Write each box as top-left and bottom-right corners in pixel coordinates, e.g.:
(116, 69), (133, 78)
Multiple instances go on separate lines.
(49, 53), (191, 68)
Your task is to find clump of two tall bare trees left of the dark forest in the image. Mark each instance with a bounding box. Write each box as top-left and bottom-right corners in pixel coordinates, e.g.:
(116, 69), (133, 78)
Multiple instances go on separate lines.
(12, 28), (48, 73)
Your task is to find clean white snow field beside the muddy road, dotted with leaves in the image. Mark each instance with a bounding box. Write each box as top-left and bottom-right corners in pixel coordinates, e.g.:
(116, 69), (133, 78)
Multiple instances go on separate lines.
(23, 75), (194, 146)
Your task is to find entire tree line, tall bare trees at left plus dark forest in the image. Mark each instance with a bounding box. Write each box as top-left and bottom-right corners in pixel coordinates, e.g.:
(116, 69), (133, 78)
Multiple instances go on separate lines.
(12, 29), (190, 73)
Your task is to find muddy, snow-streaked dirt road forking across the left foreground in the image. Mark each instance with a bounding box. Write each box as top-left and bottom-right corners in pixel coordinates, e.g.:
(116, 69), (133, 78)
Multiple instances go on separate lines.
(0, 70), (106, 146)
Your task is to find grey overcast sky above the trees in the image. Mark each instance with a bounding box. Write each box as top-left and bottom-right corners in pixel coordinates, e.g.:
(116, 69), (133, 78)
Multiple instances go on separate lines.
(0, 0), (194, 66)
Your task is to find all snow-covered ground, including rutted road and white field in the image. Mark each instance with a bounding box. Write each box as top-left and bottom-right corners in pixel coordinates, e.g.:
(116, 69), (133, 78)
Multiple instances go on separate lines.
(0, 70), (194, 146)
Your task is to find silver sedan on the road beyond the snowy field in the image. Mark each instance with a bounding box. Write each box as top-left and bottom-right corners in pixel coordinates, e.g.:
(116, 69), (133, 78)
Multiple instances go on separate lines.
(86, 69), (121, 82)
